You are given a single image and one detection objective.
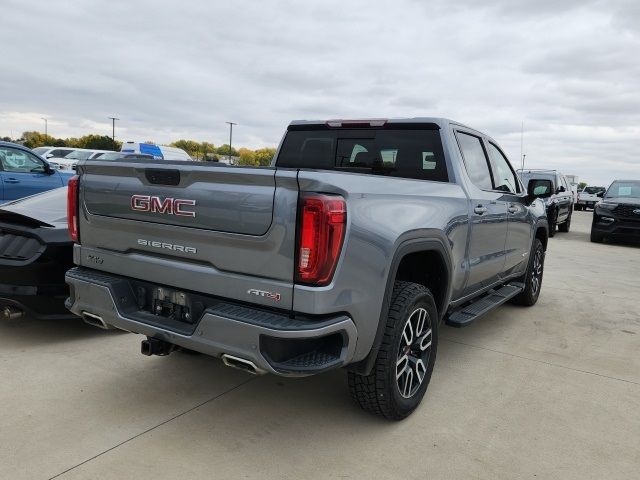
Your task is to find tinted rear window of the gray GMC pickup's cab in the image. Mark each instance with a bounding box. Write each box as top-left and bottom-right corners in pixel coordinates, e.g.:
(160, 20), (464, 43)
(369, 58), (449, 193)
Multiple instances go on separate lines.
(277, 129), (449, 182)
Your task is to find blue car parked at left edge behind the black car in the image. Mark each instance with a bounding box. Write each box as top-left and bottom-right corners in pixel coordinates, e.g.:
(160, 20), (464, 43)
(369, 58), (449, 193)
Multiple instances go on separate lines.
(0, 142), (73, 203)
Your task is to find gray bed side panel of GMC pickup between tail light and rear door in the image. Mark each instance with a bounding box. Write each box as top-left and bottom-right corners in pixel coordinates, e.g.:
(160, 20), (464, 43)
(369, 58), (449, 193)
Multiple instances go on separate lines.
(293, 170), (469, 361)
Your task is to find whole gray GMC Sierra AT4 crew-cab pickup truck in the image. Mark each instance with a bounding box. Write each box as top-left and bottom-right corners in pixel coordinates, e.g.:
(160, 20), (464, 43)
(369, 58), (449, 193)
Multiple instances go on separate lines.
(66, 118), (552, 419)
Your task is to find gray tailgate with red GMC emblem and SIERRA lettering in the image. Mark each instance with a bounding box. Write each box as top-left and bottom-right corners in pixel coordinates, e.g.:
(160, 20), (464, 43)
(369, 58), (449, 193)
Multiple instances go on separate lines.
(75, 160), (298, 308)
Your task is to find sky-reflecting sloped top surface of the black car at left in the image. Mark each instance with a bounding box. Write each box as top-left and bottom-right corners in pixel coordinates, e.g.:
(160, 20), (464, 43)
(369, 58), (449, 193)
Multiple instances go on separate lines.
(0, 187), (67, 228)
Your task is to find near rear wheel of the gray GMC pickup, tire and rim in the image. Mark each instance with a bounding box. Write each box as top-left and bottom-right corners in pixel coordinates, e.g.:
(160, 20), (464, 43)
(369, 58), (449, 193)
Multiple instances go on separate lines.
(349, 282), (438, 420)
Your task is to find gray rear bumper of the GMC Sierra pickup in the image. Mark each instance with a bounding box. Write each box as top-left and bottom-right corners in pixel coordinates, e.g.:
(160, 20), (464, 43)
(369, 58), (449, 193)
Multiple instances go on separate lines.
(66, 268), (357, 376)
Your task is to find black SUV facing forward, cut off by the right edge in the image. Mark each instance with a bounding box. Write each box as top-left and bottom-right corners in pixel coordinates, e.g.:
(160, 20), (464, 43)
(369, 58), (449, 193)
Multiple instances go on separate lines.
(591, 180), (640, 243)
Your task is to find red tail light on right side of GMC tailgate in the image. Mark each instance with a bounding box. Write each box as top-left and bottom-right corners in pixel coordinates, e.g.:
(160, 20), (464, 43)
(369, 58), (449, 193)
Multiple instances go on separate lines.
(297, 193), (347, 286)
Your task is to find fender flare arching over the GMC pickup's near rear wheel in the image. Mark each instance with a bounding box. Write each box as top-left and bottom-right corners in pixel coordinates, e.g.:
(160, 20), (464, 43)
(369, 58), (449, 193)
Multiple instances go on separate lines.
(347, 229), (453, 375)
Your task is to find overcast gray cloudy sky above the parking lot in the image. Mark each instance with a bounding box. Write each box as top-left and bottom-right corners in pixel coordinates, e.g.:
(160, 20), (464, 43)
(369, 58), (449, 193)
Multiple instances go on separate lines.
(0, 0), (640, 184)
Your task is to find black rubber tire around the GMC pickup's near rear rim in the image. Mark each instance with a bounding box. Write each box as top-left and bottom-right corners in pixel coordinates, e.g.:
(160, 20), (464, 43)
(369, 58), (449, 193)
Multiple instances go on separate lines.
(348, 281), (439, 420)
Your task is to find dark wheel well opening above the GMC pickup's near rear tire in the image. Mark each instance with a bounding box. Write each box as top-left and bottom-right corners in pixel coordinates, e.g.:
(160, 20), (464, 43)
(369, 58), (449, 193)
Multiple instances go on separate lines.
(396, 251), (449, 315)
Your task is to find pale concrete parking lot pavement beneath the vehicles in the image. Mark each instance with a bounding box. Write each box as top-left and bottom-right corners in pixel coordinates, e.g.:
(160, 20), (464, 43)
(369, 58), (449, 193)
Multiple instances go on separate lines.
(0, 212), (640, 480)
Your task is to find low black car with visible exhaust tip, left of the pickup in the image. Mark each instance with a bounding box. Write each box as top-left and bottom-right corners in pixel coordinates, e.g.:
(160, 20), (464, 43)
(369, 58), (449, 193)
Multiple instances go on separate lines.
(0, 188), (73, 319)
